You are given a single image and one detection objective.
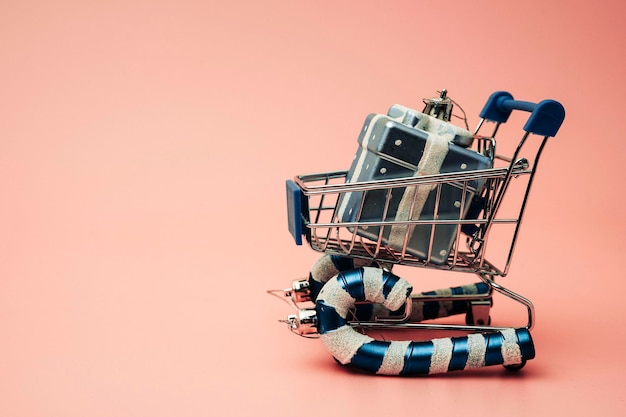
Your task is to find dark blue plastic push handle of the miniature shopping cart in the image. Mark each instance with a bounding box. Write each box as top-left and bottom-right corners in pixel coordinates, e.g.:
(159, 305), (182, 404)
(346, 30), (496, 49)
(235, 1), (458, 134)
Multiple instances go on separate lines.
(480, 91), (565, 136)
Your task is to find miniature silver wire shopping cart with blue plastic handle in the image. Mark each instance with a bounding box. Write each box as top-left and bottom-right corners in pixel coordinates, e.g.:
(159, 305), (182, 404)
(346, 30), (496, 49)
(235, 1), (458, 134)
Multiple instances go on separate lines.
(276, 92), (565, 370)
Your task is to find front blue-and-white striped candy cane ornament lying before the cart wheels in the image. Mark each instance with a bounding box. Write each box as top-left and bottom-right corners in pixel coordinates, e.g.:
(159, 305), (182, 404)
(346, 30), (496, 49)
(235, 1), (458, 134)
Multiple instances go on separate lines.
(315, 267), (535, 375)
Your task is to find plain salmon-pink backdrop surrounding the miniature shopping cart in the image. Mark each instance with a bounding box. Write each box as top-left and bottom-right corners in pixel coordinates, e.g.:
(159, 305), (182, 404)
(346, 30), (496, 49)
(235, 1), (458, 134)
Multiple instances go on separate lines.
(0, 0), (626, 417)
